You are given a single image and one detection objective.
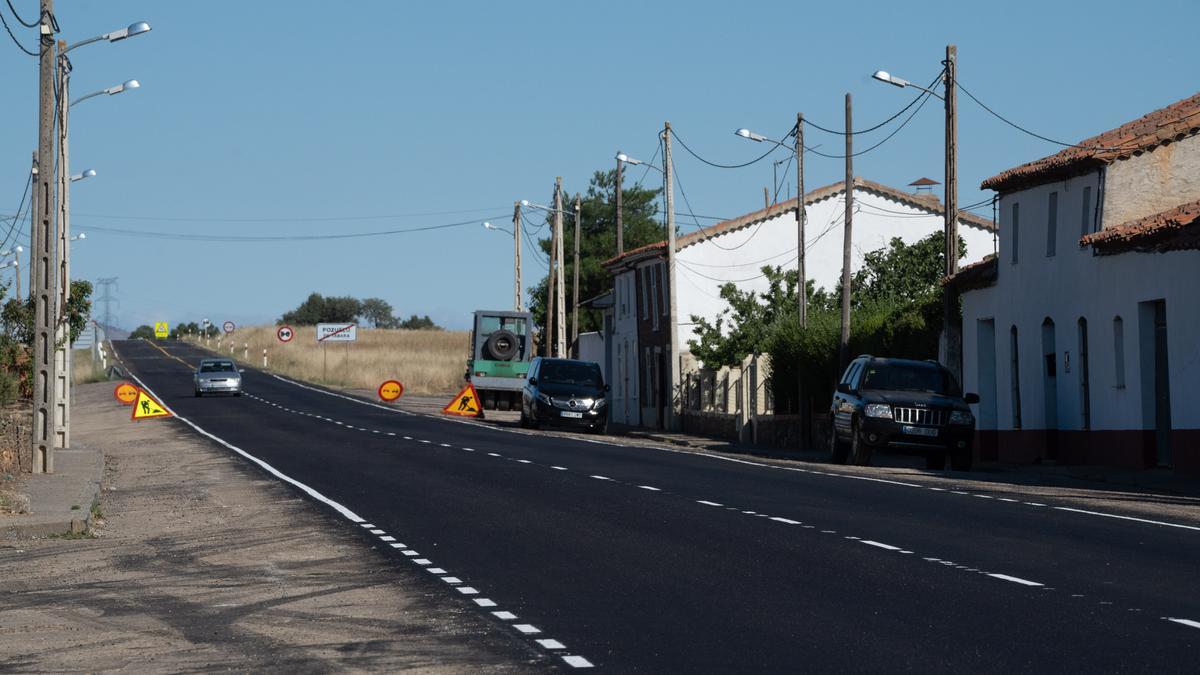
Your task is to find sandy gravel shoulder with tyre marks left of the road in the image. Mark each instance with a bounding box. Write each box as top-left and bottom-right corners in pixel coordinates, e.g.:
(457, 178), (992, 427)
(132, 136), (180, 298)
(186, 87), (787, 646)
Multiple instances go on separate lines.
(0, 383), (545, 673)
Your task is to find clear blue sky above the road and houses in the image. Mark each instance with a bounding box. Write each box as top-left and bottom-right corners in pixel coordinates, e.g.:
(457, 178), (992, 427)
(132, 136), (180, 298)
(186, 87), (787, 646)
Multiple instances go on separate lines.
(0, 0), (1200, 327)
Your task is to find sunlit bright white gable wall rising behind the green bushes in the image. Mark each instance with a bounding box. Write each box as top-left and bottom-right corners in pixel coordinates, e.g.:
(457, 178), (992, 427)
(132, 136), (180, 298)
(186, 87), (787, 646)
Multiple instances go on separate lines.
(676, 183), (994, 351)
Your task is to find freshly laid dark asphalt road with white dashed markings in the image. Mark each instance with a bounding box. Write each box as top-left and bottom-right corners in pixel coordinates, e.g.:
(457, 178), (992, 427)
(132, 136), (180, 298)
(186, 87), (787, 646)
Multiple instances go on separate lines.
(116, 341), (1200, 673)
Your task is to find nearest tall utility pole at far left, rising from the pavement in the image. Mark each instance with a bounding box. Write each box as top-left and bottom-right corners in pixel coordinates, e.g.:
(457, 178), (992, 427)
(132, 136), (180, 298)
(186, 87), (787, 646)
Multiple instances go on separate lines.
(29, 0), (58, 473)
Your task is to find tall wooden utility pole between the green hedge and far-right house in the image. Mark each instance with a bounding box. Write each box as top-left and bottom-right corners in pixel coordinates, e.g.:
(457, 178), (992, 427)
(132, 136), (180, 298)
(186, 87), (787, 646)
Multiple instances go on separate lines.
(942, 44), (962, 382)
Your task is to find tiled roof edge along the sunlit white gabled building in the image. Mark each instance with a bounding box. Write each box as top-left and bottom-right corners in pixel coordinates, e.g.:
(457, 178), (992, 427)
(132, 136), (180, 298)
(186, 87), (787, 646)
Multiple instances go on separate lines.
(604, 178), (995, 267)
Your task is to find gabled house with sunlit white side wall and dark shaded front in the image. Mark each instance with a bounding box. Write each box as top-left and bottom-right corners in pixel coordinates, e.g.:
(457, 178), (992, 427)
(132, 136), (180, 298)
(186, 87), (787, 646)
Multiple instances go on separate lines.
(605, 178), (995, 426)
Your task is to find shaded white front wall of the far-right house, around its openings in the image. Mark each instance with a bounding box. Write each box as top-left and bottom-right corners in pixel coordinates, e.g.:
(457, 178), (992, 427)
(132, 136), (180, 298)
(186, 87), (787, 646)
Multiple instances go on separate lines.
(962, 173), (1200, 430)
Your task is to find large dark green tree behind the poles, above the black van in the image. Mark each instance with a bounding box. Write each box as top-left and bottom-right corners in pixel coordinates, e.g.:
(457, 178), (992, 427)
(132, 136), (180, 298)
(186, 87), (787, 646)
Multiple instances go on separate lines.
(526, 169), (666, 333)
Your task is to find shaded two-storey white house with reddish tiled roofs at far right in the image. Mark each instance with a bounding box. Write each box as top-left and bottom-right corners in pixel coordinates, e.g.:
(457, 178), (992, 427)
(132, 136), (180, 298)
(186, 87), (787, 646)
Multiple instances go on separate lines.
(949, 90), (1200, 472)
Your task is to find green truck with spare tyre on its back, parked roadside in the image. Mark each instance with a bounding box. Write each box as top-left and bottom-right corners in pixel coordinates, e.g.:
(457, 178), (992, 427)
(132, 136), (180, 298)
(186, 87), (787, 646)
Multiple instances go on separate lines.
(467, 310), (534, 411)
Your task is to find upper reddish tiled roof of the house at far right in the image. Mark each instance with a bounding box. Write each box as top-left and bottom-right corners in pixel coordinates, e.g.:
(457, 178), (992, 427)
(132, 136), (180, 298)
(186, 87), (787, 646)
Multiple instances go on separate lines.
(982, 94), (1200, 192)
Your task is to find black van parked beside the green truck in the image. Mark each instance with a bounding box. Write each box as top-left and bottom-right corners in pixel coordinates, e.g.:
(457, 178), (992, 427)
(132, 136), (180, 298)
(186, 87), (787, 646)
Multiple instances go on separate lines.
(521, 357), (608, 434)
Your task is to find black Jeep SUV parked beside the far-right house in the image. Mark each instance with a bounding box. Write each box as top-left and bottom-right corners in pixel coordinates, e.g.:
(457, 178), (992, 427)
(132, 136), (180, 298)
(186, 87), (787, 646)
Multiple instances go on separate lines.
(829, 356), (979, 471)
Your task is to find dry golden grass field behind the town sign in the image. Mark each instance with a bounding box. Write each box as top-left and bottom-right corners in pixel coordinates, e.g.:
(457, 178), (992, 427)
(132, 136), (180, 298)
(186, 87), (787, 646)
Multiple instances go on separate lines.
(192, 325), (469, 395)
